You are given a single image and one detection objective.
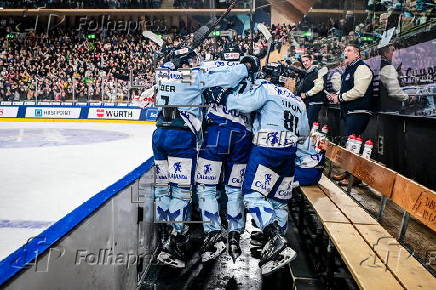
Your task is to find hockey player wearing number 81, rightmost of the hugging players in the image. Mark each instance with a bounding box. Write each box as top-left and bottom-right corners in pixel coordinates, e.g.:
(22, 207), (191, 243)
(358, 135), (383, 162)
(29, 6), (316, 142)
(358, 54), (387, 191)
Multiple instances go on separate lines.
(221, 64), (309, 275)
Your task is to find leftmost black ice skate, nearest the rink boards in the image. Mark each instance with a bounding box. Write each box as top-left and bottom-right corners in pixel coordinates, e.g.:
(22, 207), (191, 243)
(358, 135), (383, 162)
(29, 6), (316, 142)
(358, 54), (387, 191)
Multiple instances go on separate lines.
(157, 234), (187, 268)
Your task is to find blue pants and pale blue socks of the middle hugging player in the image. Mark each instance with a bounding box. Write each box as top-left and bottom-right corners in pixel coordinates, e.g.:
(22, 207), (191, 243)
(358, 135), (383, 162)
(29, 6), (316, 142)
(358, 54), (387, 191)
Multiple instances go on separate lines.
(196, 125), (252, 233)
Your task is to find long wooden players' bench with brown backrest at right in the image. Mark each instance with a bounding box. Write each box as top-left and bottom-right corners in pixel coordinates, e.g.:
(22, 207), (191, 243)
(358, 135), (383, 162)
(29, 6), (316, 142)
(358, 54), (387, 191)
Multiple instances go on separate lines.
(301, 143), (436, 289)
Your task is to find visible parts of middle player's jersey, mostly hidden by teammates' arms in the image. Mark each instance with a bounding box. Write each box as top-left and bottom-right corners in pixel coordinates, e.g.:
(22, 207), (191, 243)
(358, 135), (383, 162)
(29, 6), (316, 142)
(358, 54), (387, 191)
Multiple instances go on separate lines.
(201, 61), (253, 131)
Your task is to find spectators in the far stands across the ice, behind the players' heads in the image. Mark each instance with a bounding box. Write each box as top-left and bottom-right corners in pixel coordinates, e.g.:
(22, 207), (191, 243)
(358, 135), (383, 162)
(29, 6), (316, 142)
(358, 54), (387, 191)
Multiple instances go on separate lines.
(0, 23), (289, 101)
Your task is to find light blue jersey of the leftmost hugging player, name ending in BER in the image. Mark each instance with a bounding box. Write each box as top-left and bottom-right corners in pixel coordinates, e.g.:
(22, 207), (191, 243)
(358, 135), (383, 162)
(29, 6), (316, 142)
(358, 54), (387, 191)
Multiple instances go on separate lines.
(156, 63), (248, 133)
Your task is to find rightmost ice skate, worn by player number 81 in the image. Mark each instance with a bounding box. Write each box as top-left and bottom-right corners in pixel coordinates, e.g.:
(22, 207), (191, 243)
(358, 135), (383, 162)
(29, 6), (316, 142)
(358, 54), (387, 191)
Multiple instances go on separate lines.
(259, 223), (296, 275)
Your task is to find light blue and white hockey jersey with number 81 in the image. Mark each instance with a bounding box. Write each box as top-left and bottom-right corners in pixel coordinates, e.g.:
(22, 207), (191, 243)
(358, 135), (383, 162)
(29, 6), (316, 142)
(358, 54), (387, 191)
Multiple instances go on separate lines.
(227, 80), (309, 148)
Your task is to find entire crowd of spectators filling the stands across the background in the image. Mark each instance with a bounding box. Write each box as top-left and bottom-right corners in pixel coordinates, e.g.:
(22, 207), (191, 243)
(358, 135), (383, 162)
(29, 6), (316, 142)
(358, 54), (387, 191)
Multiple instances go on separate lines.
(0, 0), (434, 101)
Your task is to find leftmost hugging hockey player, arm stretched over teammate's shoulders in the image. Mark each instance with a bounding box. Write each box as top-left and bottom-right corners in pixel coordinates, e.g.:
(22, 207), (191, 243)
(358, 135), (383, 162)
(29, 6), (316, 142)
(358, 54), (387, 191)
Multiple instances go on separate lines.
(152, 47), (254, 268)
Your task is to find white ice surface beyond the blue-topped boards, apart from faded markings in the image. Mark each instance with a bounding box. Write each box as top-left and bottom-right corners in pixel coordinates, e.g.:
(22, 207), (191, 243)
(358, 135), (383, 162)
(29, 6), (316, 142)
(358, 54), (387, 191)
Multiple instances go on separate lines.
(0, 122), (155, 260)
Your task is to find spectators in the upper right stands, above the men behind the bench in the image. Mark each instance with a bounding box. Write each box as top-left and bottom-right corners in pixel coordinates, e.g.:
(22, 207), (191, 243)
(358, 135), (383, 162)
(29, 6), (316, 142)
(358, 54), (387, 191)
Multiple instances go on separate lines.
(291, 0), (436, 64)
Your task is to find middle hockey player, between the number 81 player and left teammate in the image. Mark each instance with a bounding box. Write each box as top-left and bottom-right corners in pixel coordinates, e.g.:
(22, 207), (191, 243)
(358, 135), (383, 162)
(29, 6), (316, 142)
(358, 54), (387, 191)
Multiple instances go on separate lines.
(196, 47), (257, 262)
